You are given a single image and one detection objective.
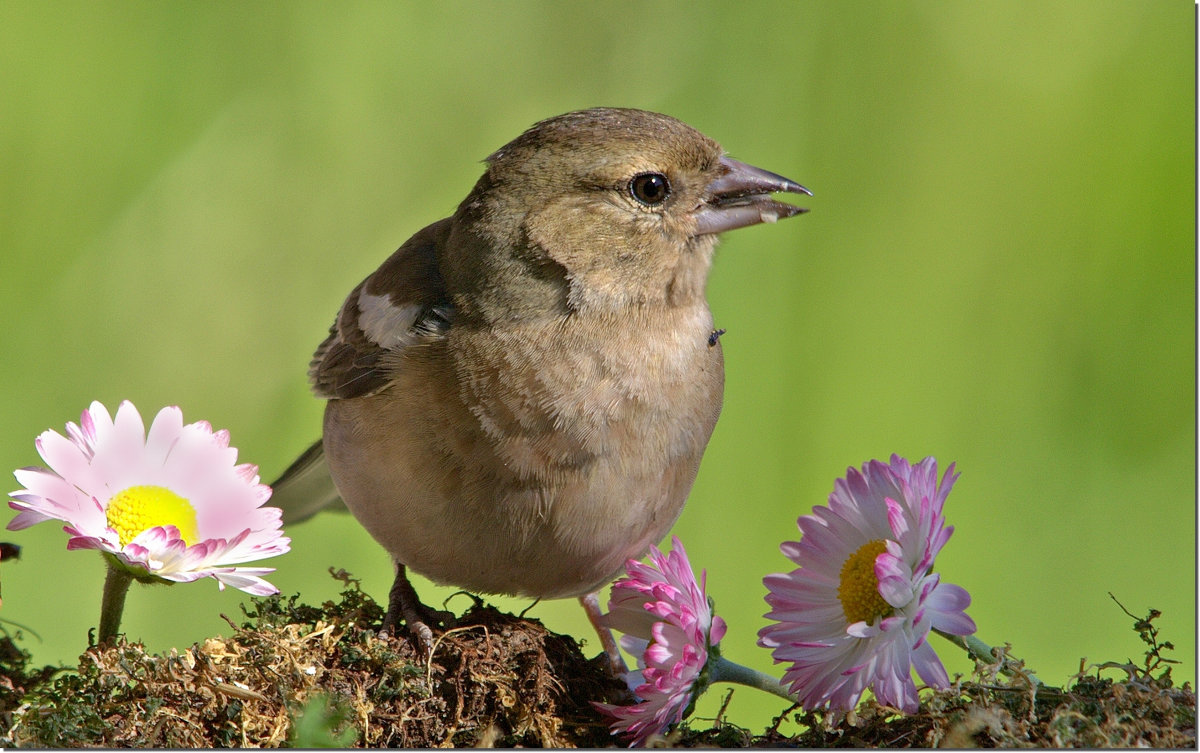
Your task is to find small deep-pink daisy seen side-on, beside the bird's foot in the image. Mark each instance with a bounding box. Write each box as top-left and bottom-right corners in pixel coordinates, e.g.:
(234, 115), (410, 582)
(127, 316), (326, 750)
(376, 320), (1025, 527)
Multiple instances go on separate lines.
(595, 537), (725, 747)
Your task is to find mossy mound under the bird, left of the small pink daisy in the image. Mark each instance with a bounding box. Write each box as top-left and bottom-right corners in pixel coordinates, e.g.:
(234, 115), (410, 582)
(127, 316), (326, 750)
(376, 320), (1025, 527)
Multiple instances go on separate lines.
(2, 575), (624, 748)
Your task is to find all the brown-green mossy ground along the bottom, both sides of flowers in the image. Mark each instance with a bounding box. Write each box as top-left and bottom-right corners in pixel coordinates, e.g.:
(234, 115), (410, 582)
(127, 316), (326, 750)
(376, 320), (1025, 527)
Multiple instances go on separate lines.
(0, 573), (1196, 748)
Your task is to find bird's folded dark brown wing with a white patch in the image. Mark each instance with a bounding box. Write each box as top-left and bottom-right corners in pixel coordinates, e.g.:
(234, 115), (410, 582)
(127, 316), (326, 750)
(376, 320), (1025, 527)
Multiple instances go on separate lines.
(308, 218), (454, 399)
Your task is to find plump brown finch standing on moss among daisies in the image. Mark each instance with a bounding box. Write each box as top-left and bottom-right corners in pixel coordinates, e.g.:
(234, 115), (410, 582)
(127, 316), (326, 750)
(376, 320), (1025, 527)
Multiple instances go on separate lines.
(272, 108), (811, 658)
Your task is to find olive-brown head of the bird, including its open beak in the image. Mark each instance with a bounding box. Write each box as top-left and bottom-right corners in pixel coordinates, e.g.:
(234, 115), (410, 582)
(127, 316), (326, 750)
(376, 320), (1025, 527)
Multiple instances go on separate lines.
(444, 108), (809, 311)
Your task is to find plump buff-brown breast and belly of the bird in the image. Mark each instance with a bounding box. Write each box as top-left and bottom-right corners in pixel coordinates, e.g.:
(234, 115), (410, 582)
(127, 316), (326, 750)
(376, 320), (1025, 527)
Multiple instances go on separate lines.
(325, 303), (724, 597)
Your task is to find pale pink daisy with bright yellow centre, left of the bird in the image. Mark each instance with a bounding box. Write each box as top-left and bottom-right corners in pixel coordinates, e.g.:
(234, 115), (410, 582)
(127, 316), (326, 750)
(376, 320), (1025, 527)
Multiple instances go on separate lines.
(8, 402), (290, 638)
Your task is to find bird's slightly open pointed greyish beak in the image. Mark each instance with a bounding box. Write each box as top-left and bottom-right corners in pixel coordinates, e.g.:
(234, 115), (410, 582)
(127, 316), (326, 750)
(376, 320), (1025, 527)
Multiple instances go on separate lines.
(695, 157), (812, 235)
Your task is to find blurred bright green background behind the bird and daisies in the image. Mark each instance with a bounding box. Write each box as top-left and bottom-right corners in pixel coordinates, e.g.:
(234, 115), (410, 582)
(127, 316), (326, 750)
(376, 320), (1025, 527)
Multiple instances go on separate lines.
(0, 0), (1196, 725)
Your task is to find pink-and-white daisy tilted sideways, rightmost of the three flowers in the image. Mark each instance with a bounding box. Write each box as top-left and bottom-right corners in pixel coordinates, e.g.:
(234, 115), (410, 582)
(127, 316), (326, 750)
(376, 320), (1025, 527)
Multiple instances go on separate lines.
(758, 454), (976, 713)
